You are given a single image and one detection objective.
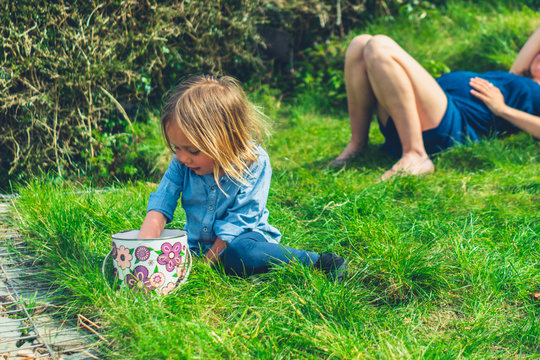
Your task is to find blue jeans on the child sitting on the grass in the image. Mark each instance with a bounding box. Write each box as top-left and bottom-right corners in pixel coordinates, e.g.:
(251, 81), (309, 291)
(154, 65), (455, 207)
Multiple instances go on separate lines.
(221, 231), (319, 276)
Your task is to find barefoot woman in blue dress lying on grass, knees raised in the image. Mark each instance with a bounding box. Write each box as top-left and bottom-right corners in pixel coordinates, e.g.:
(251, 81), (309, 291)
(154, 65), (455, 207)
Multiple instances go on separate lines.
(328, 27), (540, 180)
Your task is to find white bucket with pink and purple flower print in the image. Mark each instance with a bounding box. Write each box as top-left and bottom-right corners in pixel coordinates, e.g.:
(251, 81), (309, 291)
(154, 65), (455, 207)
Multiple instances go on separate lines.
(102, 229), (191, 295)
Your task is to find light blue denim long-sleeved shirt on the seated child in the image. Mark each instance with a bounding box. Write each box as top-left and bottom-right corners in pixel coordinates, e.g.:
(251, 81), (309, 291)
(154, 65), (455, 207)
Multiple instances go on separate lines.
(147, 147), (281, 252)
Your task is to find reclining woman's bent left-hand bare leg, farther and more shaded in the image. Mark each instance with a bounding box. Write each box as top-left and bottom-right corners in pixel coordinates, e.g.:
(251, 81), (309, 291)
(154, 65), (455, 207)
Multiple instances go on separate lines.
(328, 35), (376, 167)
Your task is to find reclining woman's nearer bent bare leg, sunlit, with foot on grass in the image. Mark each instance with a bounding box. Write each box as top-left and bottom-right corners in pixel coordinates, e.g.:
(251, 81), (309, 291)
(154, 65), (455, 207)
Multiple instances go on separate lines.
(363, 35), (448, 180)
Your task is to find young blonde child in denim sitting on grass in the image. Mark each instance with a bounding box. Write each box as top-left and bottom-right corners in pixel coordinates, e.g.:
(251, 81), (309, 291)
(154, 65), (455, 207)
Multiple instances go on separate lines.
(139, 76), (347, 281)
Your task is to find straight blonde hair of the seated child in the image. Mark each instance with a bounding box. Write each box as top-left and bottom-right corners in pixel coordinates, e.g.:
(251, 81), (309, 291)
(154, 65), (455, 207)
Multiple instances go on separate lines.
(161, 75), (268, 186)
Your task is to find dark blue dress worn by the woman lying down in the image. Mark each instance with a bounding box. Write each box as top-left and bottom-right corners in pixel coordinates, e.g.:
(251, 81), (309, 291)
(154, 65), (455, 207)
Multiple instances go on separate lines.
(379, 71), (540, 157)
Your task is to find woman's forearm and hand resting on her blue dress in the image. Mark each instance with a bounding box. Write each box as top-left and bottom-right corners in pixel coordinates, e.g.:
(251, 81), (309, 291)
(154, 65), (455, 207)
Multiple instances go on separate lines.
(470, 78), (540, 139)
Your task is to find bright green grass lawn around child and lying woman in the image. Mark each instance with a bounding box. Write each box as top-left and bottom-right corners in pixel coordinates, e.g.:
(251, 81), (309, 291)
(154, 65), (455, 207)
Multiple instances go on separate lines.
(5, 0), (540, 359)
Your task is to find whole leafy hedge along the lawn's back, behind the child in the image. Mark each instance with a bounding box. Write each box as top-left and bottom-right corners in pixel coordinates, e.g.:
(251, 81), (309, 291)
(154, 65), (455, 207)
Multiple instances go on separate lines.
(0, 0), (458, 188)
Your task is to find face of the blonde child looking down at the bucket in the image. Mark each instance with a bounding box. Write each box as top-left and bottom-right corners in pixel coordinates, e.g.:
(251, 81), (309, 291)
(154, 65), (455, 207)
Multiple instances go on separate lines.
(167, 121), (214, 175)
